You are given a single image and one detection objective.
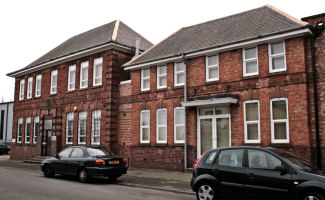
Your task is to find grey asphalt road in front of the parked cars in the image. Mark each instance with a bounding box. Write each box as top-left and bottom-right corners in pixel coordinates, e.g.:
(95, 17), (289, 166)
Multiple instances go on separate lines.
(0, 167), (195, 200)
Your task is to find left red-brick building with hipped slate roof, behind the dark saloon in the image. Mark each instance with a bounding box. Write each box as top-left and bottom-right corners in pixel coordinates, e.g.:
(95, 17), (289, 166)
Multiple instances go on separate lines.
(8, 20), (152, 159)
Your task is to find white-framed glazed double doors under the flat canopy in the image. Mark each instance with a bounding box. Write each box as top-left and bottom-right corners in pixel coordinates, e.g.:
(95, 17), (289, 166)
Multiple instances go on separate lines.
(197, 106), (231, 158)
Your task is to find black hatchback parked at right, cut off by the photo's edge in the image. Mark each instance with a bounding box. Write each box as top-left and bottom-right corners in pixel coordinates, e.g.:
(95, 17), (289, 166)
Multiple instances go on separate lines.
(191, 147), (325, 200)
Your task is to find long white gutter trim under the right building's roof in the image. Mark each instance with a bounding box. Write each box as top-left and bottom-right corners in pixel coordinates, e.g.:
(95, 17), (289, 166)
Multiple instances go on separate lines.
(124, 28), (312, 70)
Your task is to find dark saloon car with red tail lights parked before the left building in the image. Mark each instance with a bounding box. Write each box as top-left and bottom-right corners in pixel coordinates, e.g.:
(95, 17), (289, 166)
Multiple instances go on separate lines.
(41, 146), (128, 183)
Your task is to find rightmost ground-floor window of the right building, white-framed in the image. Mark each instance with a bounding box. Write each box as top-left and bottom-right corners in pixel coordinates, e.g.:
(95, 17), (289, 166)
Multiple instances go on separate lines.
(271, 98), (289, 143)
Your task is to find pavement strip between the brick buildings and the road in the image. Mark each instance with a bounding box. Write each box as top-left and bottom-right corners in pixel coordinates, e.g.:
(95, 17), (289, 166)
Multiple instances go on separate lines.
(0, 156), (194, 194)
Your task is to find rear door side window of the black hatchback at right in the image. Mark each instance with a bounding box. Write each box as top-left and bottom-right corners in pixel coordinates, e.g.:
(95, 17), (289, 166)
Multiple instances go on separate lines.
(218, 149), (243, 167)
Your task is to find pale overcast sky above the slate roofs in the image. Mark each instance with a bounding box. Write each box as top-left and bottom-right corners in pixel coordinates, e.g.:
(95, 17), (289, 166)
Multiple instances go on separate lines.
(0, 0), (325, 101)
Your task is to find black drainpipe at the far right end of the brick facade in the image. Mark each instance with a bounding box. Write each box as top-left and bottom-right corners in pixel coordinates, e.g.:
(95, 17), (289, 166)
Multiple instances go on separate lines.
(311, 22), (324, 169)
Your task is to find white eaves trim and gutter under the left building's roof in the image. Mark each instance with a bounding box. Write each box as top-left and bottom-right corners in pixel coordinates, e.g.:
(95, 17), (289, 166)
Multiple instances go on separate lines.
(8, 43), (133, 77)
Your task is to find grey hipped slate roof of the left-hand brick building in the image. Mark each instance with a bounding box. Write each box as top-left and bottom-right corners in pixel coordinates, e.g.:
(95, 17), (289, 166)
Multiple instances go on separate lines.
(19, 20), (152, 69)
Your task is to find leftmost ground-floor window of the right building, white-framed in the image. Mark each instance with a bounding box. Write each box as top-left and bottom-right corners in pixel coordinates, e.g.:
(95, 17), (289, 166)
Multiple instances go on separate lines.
(140, 110), (150, 143)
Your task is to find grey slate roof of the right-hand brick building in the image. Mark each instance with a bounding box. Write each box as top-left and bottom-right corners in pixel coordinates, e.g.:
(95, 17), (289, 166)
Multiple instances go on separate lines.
(124, 5), (307, 66)
